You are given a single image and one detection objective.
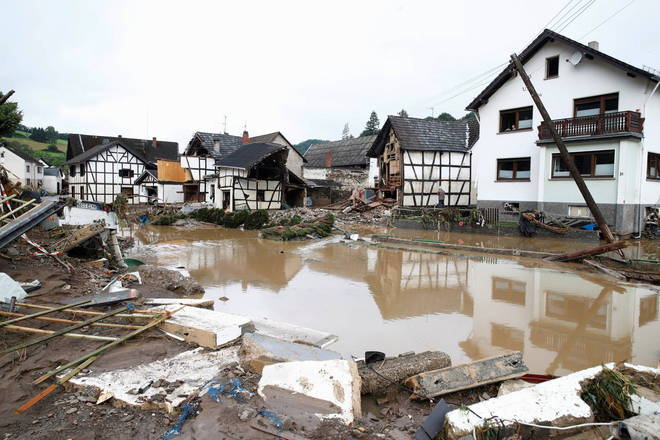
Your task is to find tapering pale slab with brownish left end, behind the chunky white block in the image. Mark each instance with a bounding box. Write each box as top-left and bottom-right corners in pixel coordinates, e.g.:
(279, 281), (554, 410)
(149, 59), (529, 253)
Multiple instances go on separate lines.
(240, 333), (341, 374)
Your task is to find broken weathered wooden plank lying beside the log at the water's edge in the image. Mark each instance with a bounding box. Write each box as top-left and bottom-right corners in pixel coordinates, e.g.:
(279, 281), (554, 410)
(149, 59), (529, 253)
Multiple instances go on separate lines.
(406, 351), (528, 399)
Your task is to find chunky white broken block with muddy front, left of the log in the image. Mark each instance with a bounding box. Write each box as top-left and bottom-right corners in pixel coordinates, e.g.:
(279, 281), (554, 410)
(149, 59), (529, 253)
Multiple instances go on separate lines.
(258, 360), (362, 429)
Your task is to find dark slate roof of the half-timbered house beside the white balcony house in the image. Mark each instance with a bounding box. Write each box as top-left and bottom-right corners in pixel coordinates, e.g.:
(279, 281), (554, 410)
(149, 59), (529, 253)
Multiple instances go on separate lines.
(367, 116), (479, 157)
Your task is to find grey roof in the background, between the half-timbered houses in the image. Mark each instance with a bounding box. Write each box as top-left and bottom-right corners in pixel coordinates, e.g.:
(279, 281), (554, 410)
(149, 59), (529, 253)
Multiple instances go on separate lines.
(304, 135), (376, 168)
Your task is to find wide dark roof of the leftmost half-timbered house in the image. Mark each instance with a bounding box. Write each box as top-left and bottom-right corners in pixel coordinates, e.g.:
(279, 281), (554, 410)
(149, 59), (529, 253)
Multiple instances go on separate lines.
(66, 134), (179, 164)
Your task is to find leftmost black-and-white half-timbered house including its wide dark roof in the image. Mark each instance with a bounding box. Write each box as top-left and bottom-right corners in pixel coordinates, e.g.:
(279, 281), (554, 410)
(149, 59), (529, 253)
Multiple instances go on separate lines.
(65, 134), (178, 204)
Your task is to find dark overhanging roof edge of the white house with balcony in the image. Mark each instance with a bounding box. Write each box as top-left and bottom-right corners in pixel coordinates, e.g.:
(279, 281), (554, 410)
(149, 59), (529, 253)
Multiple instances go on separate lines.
(465, 29), (660, 111)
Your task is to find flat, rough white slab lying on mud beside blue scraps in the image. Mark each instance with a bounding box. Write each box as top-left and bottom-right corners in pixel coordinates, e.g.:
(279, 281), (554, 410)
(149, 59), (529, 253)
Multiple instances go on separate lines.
(69, 347), (238, 412)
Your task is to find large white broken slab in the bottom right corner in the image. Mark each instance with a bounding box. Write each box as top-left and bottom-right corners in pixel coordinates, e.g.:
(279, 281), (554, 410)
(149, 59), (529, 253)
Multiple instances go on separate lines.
(445, 364), (660, 439)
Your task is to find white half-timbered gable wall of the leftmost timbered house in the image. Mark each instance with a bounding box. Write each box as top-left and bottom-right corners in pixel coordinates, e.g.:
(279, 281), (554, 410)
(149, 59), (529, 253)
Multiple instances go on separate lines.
(69, 145), (147, 204)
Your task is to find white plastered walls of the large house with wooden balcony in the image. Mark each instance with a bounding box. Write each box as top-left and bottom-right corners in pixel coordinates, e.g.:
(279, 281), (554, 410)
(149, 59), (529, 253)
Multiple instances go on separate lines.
(473, 42), (660, 233)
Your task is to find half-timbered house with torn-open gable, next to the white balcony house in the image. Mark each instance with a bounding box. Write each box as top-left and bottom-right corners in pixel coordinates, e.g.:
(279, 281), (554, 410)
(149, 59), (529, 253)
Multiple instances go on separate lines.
(367, 116), (479, 207)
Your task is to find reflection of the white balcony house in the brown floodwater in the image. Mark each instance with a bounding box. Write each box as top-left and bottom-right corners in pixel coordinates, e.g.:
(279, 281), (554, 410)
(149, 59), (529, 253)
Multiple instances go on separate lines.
(462, 263), (660, 374)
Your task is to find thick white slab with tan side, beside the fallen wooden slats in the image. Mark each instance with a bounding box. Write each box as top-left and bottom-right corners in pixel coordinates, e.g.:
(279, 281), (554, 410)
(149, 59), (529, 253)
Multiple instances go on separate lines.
(160, 305), (254, 348)
